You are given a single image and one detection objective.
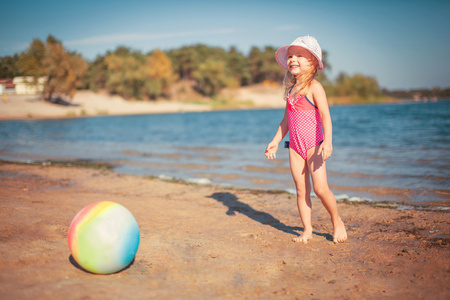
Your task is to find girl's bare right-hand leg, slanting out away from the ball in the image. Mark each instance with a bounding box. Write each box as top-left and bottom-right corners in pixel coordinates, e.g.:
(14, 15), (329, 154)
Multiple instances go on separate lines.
(307, 146), (347, 243)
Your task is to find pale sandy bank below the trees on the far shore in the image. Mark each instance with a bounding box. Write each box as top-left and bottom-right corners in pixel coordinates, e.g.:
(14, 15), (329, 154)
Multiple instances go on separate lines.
(0, 85), (285, 120)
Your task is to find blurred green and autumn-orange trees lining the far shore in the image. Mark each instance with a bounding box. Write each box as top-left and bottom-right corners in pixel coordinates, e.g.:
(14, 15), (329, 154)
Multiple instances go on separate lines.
(0, 35), (442, 100)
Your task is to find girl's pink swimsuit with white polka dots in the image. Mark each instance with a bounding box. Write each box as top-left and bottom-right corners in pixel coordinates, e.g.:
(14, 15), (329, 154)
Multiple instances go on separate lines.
(286, 92), (323, 160)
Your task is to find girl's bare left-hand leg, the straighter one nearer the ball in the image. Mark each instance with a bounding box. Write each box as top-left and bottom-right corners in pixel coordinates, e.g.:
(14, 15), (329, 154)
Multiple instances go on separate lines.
(289, 149), (312, 244)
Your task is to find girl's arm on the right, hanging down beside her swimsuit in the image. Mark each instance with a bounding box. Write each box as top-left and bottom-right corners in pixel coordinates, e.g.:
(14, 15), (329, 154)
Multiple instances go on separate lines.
(311, 80), (333, 161)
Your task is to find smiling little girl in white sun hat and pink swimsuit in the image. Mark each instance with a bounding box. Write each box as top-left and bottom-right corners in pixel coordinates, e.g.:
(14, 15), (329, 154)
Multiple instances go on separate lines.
(265, 36), (347, 244)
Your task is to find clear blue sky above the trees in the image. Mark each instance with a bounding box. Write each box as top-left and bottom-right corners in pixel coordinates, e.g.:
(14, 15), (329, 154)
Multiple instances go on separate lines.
(0, 0), (450, 89)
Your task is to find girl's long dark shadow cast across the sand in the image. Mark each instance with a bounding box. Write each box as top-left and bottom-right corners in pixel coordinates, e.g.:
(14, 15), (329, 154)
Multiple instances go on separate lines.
(208, 193), (333, 241)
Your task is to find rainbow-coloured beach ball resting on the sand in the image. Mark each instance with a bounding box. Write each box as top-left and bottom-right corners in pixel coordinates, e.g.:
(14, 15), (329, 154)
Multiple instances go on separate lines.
(68, 201), (140, 274)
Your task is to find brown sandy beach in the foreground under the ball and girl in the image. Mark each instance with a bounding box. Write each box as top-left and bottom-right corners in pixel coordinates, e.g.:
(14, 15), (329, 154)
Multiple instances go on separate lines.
(0, 163), (450, 299)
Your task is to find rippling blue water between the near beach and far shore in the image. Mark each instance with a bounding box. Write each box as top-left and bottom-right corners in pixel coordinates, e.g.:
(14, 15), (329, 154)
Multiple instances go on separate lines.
(0, 100), (450, 203)
